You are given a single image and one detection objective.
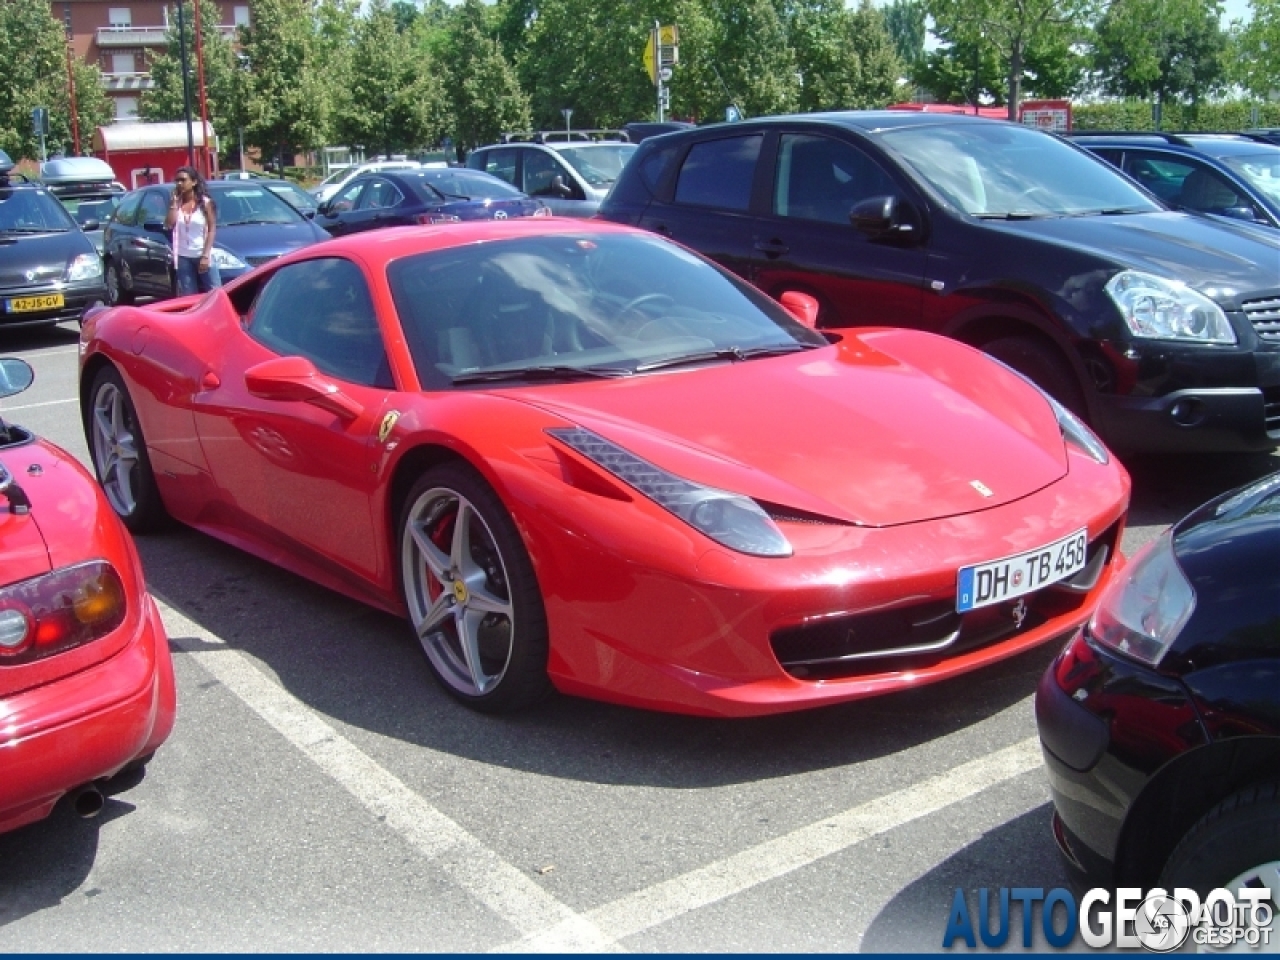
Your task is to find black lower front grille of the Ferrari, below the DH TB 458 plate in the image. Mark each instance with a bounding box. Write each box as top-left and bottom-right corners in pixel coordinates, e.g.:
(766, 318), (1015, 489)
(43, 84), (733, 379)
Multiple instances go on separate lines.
(769, 525), (1119, 681)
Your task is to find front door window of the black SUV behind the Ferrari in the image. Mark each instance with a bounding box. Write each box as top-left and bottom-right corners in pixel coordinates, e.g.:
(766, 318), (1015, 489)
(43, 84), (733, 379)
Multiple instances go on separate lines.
(773, 134), (897, 224)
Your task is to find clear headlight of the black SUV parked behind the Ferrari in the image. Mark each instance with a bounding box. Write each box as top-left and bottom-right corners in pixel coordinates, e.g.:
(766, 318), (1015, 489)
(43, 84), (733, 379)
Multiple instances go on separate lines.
(1106, 270), (1235, 343)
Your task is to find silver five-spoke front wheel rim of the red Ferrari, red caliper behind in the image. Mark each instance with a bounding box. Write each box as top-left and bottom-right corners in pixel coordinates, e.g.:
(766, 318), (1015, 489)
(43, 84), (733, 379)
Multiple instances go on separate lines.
(401, 486), (516, 698)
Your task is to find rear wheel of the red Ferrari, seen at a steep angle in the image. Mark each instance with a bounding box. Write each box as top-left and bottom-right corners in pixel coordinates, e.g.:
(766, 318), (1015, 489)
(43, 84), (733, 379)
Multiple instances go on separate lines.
(84, 366), (168, 534)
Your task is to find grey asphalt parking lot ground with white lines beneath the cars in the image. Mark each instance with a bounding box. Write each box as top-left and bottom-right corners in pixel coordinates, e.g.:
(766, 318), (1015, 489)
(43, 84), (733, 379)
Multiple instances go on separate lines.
(0, 326), (1280, 952)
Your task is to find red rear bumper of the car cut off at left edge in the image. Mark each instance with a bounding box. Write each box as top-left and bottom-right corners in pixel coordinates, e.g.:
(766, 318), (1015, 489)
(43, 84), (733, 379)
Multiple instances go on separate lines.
(0, 596), (175, 832)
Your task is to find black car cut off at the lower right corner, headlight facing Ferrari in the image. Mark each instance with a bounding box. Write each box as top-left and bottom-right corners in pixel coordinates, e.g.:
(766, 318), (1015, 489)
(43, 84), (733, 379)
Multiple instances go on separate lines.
(1036, 474), (1280, 911)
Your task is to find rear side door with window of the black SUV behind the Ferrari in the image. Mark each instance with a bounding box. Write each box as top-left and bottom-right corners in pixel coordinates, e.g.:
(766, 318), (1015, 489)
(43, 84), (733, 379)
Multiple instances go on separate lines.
(639, 132), (764, 279)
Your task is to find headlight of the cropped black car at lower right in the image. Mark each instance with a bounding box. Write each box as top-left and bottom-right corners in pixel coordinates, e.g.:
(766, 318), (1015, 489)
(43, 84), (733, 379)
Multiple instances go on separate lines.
(1089, 531), (1196, 667)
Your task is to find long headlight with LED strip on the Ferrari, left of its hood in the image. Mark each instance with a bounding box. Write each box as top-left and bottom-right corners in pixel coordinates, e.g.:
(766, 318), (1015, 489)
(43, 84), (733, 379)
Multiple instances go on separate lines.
(547, 426), (792, 557)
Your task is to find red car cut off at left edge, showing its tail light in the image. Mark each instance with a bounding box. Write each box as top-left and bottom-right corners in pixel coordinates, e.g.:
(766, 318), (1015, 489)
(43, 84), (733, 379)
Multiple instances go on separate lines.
(0, 360), (174, 832)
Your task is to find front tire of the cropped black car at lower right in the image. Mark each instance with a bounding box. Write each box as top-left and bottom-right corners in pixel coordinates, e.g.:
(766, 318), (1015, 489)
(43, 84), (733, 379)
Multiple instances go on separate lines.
(1160, 782), (1280, 905)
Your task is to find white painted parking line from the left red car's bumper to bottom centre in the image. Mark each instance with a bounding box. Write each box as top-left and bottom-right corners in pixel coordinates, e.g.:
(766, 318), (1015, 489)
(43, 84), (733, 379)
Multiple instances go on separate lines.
(157, 602), (612, 952)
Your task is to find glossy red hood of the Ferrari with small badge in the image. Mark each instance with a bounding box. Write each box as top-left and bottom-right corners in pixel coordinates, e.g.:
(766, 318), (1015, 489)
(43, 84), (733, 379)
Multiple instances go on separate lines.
(502, 330), (1068, 526)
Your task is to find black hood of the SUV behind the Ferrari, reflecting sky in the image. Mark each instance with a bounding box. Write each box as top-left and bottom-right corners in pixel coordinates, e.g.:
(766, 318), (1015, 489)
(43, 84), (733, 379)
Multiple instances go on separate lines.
(998, 211), (1280, 307)
